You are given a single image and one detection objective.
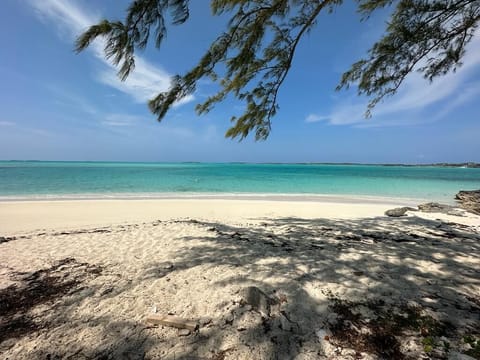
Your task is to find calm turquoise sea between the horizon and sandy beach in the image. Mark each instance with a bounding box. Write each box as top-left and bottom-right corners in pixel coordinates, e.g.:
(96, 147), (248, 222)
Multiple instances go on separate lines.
(0, 161), (480, 202)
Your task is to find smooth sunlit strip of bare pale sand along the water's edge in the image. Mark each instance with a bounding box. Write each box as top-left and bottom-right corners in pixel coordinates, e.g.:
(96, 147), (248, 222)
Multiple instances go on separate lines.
(0, 196), (412, 235)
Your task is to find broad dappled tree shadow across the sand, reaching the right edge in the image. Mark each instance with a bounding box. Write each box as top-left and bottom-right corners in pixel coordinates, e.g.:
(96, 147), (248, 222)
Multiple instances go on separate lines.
(0, 217), (480, 360)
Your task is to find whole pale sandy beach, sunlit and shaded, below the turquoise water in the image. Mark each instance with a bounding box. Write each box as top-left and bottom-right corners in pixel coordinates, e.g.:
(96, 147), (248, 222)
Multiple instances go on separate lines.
(0, 199), (480, 360)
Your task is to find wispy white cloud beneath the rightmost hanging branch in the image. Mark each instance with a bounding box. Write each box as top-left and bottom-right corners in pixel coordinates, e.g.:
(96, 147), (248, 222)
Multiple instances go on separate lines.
(305, 32), (480, 127)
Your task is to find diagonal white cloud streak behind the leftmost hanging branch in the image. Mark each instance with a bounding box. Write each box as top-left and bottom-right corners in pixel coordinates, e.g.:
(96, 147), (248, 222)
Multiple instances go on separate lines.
(29, 0), (194, 105)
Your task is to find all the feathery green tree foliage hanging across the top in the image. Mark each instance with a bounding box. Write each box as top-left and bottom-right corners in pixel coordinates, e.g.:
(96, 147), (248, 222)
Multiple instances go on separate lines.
(76, 0), (480, 140)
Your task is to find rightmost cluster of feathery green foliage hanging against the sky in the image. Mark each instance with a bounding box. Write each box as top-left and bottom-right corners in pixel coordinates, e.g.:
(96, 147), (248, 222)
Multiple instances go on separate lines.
(338, 0), (480, 116)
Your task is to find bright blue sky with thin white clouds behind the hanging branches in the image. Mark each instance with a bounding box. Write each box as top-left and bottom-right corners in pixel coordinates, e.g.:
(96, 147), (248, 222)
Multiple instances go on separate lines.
(0, 0), (480, 163)
